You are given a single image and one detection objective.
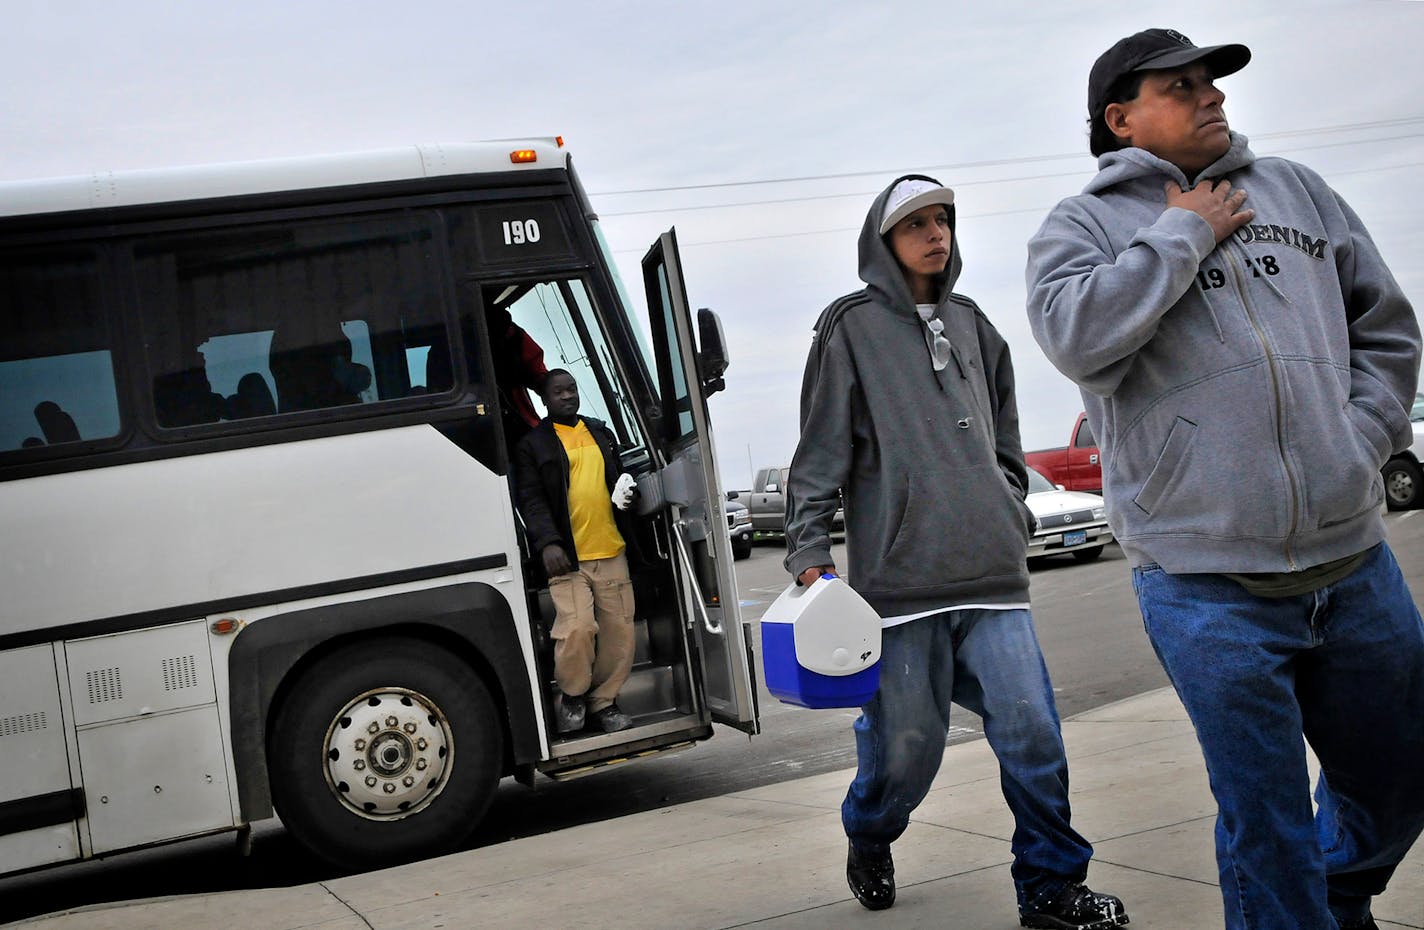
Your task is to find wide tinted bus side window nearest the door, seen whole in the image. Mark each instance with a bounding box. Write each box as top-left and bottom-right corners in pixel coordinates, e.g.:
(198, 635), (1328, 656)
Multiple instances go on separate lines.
(135, 215), (454, 427)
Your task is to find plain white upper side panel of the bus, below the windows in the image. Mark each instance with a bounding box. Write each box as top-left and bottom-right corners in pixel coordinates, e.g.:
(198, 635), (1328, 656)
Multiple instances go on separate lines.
(0, 426), (518, 637)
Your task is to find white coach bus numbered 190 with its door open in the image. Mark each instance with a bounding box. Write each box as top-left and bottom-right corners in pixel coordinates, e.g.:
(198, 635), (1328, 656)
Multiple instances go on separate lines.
(0, 140), (758, 873)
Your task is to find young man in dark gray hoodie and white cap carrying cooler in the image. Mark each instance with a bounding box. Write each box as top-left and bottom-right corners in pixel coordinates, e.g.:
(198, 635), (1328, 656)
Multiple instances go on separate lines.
(786, 175), (1128, 930)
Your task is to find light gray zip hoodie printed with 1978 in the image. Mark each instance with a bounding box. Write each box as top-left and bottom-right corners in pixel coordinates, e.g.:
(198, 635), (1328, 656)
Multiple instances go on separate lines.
(1027, 134), (1420, 573)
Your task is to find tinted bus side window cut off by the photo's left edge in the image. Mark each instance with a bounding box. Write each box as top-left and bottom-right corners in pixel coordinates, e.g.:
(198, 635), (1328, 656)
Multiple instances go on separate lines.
(0, 252), (120, 451)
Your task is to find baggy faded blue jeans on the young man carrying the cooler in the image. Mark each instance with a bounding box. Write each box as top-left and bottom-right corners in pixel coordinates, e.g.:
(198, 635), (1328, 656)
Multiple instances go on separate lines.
(840, 610), (1092, 907)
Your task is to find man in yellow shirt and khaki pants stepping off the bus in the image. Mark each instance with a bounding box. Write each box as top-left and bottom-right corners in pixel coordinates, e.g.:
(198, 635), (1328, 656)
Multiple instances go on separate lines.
(514, 369), (634, 733)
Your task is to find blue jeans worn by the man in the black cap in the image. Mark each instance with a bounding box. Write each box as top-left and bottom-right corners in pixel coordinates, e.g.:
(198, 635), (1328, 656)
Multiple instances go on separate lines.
(1132, 543), (1424, 930)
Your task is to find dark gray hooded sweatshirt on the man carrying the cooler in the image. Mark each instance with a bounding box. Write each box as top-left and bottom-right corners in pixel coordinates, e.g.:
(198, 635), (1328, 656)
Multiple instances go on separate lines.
(786, 175), (1032, 617)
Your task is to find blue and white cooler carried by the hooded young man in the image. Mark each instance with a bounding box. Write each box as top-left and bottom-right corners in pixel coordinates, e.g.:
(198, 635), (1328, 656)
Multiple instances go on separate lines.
(762, 575), (880, 708)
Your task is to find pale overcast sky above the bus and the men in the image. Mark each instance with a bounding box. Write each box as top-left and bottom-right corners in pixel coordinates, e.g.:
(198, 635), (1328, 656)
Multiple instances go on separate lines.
(0, 0), (1424, 487)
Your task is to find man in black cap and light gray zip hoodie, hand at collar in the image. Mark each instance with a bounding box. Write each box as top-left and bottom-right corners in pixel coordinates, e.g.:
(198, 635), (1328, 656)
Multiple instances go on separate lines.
(1028, 28), (1424, 930)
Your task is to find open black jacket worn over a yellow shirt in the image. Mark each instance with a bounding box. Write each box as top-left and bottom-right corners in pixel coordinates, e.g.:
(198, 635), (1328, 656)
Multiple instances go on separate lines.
(514, 417), (631, 568)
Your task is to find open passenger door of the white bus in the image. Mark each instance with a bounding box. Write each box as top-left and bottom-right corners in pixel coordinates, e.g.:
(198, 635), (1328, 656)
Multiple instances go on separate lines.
(642, 229), (760, 733)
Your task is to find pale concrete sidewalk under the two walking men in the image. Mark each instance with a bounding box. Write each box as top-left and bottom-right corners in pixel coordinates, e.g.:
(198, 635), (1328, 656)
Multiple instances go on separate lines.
(13, 689), (1424, 930)
